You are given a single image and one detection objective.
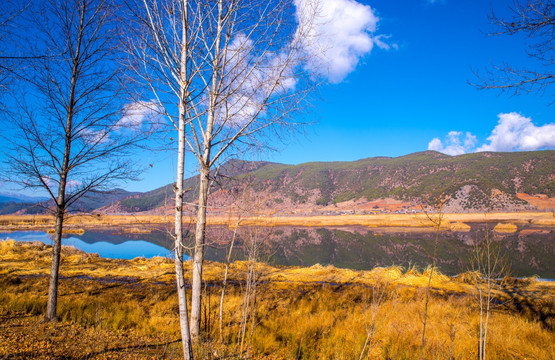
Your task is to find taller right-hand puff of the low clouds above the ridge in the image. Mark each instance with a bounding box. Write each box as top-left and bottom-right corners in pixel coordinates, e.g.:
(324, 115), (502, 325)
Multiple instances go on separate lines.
(476, 112), (555, 151)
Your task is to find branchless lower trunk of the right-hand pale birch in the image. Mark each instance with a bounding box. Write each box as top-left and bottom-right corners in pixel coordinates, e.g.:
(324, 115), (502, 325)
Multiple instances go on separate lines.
(191, 167), (210, 338)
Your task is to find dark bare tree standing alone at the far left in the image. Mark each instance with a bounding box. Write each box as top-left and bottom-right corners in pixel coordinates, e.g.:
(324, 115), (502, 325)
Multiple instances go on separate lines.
(2, 0), (143, 321)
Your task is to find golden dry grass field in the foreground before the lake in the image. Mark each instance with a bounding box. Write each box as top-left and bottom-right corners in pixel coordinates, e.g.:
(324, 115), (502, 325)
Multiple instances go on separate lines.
(0, 241), (555, 360)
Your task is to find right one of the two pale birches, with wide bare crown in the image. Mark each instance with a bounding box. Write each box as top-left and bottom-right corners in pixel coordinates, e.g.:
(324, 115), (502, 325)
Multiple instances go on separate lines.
(182, 0), (316, 337)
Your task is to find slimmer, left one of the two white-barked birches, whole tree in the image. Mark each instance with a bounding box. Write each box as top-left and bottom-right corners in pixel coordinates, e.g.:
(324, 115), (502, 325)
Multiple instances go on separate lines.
(127, 0), (200, 359)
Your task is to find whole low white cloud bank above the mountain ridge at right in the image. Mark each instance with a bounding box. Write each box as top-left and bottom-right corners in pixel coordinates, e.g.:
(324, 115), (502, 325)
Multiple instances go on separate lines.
(428, 112), (555, 155)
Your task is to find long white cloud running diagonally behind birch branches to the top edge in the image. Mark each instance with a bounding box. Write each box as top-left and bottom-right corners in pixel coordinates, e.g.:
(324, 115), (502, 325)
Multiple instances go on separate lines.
(213, 0), (390, 127)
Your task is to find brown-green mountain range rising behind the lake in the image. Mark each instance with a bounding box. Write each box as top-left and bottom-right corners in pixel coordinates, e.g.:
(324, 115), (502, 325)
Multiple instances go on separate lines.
(6, 151), (555, 215)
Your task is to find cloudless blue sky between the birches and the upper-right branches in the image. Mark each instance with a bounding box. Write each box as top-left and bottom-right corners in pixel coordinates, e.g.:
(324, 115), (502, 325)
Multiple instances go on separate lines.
(271, 0), (555, 163)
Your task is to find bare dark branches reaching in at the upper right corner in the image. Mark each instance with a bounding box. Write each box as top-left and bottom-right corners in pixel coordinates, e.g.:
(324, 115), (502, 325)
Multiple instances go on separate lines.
(474, 0), (555, 95)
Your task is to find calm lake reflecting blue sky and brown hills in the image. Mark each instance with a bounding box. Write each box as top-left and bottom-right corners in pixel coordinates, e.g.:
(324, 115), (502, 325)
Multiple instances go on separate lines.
(0, 224), (555, 278)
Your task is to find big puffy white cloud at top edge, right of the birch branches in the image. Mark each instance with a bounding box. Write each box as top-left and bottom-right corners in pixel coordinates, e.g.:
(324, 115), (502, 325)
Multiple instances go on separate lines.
(295, 0), (390, 83)
